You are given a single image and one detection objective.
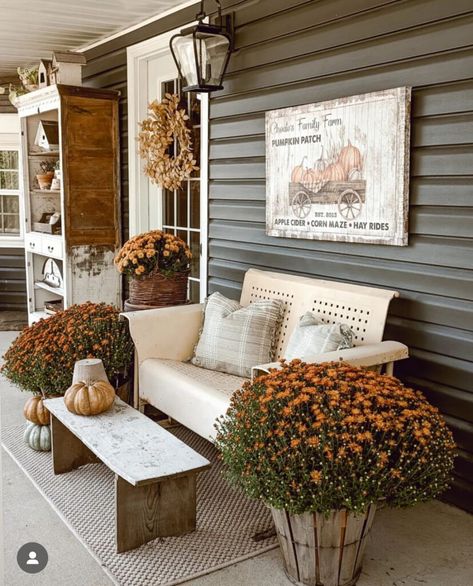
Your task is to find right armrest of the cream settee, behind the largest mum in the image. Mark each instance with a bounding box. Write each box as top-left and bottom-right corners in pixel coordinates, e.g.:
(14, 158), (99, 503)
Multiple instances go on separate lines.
(251, 340), (409, 379)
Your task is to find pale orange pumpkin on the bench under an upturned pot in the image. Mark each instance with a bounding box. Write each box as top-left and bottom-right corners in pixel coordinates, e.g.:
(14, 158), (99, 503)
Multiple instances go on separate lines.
(64, 380), (115, 415)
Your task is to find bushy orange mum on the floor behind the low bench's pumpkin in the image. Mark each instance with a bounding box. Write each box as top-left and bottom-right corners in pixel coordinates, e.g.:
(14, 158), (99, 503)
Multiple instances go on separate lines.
(1, 302), (133, 395)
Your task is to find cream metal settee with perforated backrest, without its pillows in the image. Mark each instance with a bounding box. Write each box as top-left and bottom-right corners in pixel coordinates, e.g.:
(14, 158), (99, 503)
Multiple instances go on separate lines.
(123, 269), (408, 439)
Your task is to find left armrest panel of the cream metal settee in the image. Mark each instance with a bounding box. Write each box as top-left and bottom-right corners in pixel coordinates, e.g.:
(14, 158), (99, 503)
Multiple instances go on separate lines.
(120, 304), (204, 364)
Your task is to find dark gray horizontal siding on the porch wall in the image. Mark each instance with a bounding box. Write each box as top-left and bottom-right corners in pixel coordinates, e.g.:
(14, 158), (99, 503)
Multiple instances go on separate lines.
(85, 0), (473, 508)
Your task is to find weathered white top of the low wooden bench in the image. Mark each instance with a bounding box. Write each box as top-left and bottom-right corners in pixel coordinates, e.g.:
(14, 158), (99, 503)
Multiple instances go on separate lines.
(44, 397), (210, 486)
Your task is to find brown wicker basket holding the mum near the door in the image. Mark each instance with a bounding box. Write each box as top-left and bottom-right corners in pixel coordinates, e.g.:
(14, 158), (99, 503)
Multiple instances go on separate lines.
(128, 271), (189, 307)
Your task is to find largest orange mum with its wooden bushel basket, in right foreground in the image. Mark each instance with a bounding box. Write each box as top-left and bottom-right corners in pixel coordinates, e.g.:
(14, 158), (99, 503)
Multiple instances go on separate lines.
(216, 360), (455, 586)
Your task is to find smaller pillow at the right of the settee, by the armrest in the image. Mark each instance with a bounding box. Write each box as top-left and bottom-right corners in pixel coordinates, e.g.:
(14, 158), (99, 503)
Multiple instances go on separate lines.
(285, 311), (353, 362)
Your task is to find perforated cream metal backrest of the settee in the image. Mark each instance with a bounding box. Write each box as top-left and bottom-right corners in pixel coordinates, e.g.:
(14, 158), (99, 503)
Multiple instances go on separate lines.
(240, 269), (399, 357)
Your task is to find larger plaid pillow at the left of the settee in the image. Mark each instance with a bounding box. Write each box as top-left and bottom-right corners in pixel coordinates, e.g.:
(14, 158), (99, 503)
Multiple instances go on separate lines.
(192, 292), (284, 378)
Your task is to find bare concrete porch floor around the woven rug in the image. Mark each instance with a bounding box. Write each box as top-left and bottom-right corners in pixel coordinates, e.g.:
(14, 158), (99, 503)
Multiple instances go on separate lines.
(0, 332), (473, 586)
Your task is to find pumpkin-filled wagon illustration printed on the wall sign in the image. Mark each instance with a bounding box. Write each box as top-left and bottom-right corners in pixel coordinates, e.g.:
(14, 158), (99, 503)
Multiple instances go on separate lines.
(289, 141), (366, 220)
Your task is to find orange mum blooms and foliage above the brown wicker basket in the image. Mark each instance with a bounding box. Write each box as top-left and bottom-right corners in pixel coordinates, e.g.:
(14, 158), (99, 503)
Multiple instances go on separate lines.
(115, 230), (192, 279)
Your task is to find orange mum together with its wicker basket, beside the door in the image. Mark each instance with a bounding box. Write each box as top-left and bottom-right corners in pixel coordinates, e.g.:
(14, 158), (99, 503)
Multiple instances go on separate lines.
(115, 230), (192, 309)
